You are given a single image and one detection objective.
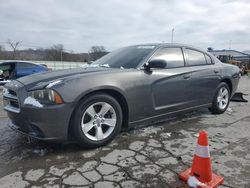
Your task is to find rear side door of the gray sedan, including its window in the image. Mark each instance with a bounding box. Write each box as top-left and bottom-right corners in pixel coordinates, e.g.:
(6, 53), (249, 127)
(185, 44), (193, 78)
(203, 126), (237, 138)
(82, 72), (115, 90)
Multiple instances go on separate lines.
(184, 48), (220, 105)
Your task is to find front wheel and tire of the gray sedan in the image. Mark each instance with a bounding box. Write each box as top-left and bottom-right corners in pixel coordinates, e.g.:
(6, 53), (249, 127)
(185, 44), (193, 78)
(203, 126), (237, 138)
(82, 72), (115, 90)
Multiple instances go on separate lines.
(71, 93), (123, 148)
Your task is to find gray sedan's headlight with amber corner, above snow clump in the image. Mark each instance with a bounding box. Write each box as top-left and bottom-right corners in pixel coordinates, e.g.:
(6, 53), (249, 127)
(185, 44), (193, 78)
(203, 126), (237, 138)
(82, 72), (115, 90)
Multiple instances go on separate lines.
(28, 89), (63, 105)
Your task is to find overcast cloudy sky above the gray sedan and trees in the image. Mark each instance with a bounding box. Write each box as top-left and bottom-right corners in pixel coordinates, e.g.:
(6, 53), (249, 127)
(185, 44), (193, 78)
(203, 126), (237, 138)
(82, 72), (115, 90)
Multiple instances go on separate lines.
(0, 0), (250, 52)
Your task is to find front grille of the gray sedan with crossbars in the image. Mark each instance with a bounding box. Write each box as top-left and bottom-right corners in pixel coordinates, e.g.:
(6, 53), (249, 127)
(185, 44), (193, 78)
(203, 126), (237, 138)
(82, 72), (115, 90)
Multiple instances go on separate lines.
(3, 88), (20, 113)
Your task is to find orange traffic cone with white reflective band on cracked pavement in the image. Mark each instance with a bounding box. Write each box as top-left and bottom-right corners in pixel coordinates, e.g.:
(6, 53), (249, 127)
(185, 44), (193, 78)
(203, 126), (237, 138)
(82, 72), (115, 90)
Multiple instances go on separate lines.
(179, 131), (224, 188)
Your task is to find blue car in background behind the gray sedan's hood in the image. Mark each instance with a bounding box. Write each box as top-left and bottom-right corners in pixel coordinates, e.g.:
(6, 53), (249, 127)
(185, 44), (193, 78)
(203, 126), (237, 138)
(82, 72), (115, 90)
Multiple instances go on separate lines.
(0, 61), (50, 85)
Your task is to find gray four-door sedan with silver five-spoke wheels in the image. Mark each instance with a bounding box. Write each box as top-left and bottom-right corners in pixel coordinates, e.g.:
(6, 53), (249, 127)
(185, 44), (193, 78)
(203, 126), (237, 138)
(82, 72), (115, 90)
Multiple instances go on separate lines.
(3, 44), (240, 148)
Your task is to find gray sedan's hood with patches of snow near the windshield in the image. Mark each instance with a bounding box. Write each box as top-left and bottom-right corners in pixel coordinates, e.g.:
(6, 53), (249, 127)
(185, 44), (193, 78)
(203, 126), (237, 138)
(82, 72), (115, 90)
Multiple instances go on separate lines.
(17, 67), (113, 89)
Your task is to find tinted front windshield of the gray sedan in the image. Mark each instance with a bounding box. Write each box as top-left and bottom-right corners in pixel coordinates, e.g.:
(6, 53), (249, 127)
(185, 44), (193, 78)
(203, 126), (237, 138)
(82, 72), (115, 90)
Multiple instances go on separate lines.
(91, 45), (155, 69)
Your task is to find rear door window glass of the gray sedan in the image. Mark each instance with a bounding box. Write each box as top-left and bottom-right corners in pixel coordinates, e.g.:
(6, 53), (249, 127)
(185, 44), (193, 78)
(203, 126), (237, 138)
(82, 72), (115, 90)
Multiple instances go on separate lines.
(185, 49), (207, 66)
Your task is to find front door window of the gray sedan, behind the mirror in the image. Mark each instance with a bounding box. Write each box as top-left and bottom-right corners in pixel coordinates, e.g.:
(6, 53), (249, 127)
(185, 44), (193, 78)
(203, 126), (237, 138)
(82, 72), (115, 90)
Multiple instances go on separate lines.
(151, 48), (184, 68)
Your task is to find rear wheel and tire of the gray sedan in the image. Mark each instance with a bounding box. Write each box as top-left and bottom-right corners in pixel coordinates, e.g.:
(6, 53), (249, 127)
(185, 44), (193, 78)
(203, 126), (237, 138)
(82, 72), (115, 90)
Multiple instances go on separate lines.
(208, 82), (231, 114)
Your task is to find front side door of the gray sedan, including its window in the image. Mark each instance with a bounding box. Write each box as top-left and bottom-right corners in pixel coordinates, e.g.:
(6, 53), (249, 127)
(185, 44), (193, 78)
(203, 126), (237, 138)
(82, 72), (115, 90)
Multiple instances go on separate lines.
(148, 47), (191, 113)
